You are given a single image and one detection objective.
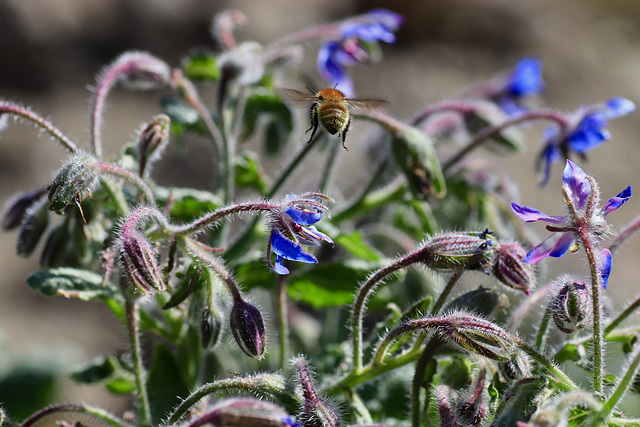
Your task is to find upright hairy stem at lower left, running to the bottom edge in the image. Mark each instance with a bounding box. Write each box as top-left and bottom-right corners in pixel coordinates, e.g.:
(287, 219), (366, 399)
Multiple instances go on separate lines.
(125, 298), (151, 426)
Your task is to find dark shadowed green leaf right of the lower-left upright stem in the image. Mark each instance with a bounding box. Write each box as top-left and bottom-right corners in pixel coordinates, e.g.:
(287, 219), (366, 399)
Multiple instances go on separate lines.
(148, 343), (189, 424)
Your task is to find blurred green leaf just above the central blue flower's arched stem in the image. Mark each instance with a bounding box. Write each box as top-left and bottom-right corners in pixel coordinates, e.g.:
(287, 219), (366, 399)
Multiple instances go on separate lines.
(156, 187), (222, 222)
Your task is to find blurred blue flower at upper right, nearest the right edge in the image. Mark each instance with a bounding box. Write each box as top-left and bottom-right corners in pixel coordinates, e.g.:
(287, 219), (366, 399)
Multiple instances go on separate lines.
(536, 97), (636, 186)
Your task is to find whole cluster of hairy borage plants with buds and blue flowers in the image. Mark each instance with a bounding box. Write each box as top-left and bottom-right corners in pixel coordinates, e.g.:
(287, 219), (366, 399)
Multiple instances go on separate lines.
(0, 9), (640, 427)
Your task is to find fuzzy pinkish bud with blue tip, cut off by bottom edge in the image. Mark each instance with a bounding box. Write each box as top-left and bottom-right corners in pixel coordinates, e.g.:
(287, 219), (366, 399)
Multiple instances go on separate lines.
(189, 398), (299, 427)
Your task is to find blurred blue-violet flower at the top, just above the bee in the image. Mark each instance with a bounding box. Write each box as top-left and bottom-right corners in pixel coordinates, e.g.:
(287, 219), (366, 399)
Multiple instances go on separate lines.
(317, 9), (404, 97)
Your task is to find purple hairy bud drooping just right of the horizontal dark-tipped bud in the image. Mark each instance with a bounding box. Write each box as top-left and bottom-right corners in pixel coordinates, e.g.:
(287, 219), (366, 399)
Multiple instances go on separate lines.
(493, 243), (534, 295)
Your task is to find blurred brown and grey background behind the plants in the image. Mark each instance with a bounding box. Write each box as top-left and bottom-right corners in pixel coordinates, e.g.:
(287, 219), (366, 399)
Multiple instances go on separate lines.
(0, 0), (640, 422)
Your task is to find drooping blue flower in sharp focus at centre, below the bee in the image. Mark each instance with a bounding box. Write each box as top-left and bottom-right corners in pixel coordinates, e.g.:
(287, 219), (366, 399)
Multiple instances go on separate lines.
(267, 193), (333, 275)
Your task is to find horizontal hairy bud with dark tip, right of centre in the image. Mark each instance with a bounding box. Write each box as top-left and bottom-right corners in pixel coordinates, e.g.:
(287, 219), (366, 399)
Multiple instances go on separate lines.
(419, 230), (495, 273)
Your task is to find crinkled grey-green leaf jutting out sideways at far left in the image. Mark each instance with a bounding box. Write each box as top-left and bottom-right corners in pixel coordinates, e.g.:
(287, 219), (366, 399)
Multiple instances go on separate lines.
(27, 267), (119, 301)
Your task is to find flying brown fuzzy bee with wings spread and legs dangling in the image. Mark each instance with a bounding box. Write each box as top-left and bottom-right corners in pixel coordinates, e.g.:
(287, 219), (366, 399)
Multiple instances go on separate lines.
(278, 87), (387, 151)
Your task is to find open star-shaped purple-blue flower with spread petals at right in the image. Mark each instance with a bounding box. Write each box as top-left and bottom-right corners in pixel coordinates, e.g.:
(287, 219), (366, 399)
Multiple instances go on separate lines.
(511, 160), (631, 264)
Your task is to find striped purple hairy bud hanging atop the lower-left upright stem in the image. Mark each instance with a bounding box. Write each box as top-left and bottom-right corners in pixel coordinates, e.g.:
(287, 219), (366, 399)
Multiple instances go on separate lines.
(118, 228), (166, 295)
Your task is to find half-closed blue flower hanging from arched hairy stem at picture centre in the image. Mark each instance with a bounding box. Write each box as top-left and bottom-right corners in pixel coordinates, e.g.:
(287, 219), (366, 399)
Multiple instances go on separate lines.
(267, 202), (333, 275)
